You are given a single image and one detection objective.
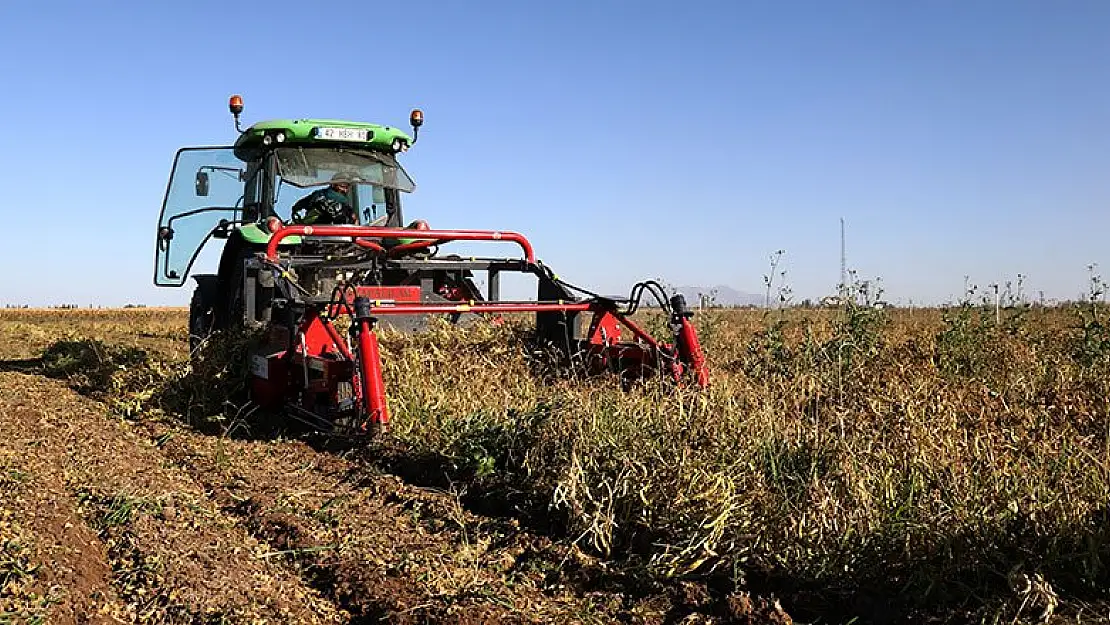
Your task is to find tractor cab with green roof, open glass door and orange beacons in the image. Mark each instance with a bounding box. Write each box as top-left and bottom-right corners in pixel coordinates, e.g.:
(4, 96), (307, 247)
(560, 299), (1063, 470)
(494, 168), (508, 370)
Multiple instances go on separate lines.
(154, 98), (423, 286)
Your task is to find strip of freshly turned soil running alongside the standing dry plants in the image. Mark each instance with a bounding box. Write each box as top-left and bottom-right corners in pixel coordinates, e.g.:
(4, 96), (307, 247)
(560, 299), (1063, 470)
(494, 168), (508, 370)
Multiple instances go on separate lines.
(143, 422), (664, 623)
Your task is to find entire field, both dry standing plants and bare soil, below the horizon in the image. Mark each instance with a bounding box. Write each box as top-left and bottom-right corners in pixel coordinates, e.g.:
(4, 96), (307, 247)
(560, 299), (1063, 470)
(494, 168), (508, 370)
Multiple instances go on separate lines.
(0, 297), (1110, 623)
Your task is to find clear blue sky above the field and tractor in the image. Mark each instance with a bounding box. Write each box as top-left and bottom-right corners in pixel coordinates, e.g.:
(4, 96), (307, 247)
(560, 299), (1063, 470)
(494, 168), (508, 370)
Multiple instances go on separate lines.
(0, 0), (1110, 305)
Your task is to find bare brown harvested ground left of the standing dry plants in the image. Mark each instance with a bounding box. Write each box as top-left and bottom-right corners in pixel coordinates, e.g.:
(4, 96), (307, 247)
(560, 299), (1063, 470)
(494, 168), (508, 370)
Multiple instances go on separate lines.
(0, 319), (789, 624)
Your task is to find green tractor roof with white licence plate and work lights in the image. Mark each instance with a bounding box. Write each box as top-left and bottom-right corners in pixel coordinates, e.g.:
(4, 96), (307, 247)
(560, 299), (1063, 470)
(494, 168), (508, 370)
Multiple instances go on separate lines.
(235, 119), (413, 158)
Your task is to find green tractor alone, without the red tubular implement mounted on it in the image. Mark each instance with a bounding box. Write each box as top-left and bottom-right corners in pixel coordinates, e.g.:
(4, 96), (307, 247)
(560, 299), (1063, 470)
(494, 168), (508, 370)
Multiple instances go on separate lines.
(154, 95), (481, 347)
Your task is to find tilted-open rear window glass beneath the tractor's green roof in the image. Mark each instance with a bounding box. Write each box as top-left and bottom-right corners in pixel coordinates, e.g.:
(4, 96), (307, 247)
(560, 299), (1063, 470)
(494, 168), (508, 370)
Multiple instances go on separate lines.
(274, 147), (416, 192)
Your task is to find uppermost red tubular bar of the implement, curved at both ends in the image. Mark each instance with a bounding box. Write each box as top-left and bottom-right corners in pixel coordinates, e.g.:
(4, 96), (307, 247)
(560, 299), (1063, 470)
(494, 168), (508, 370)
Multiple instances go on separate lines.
(266, 225), (536, 263)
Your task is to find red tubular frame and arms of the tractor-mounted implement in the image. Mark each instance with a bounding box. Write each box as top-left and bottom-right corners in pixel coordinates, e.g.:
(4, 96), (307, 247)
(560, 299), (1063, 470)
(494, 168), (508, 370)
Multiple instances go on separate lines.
(253, 225), (709, 431)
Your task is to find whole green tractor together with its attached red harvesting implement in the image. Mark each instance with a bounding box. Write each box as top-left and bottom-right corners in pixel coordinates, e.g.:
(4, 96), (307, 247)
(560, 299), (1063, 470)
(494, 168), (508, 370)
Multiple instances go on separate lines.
(154, 95), (708, 431)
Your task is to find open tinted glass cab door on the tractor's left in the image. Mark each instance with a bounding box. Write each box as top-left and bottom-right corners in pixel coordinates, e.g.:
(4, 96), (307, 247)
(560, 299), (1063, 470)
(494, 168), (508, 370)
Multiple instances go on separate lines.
(154, 148), (246, 286)
